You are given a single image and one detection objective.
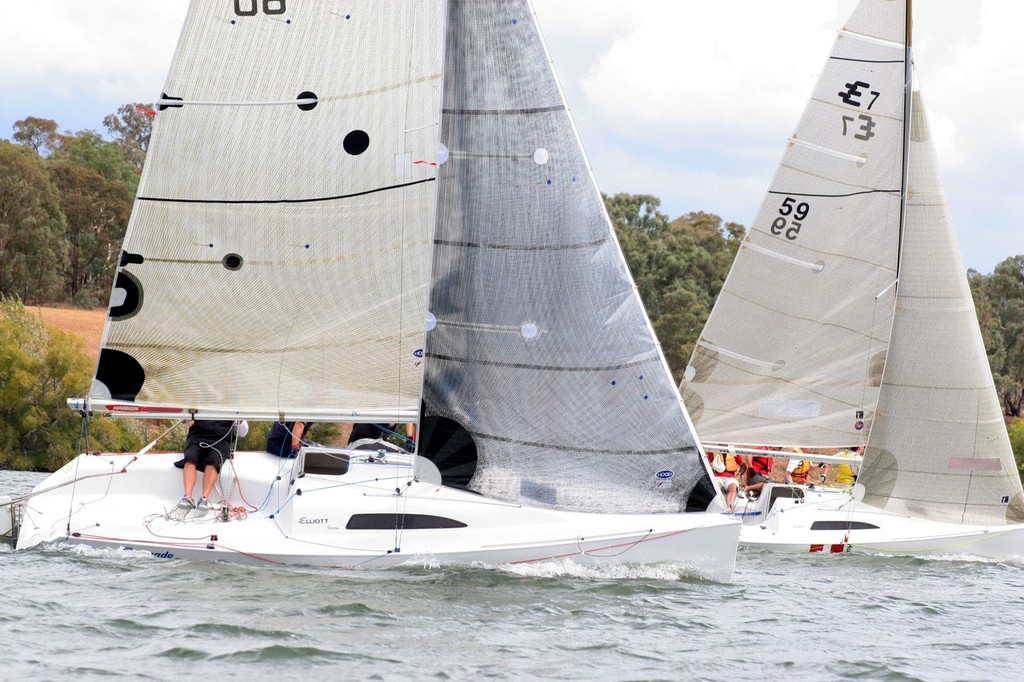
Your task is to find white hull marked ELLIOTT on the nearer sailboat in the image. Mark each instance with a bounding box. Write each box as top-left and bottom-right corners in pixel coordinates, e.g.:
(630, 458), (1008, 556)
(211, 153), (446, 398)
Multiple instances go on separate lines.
(16, 449), (740, 580)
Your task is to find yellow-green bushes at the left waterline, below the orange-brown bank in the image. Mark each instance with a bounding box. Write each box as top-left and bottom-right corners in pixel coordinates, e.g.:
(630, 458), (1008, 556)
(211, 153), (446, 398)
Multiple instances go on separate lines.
(0, 297), (138, 471)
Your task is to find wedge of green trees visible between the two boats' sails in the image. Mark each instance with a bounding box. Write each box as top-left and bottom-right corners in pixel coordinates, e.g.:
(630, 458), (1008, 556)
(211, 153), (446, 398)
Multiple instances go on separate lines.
(604, 195), (745, 381)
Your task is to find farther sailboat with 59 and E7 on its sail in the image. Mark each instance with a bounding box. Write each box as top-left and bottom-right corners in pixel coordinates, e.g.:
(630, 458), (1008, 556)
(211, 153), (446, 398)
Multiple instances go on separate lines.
(681, 0), (1024, 557)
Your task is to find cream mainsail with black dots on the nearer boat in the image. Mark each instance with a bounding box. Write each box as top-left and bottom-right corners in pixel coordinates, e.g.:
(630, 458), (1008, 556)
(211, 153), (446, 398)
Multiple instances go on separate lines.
(83, 0), (443, 419)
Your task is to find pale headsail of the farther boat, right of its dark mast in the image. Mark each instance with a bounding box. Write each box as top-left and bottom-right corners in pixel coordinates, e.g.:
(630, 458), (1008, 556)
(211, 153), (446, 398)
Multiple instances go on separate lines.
(858, 92), (1024, 524)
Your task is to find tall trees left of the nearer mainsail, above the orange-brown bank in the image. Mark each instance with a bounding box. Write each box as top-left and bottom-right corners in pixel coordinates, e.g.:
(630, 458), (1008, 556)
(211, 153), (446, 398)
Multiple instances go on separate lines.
(0, 104), (153, 307)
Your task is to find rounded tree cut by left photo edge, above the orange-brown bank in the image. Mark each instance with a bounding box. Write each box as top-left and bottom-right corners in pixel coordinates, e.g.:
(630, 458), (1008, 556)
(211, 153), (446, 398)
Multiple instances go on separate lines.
(0, 140), (68, 302)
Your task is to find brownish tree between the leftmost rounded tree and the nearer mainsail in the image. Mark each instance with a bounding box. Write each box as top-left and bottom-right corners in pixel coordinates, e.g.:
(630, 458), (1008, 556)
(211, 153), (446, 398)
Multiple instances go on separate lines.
(49, 162), (132, 307)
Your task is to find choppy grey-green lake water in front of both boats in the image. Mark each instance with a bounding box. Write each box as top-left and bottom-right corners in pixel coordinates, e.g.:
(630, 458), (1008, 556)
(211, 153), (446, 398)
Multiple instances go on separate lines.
(0, 471), (1024, 681)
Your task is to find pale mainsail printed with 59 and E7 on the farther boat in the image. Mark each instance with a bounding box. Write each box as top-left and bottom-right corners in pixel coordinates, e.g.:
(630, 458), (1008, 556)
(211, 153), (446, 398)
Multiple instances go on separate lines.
(681, 0), (906, 446)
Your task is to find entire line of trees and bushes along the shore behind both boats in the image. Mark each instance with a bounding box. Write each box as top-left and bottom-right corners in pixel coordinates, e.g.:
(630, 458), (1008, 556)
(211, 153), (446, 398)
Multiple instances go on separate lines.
(0, 103), (1024, 470)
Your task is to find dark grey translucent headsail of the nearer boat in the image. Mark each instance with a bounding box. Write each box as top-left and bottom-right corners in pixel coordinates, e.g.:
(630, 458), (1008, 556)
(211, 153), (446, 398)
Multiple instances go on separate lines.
(421, 0), (709, 512)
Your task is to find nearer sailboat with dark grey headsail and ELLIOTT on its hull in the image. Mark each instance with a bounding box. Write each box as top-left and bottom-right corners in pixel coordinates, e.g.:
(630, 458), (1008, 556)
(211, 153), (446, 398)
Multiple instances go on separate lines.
(0, 0), (740, 579)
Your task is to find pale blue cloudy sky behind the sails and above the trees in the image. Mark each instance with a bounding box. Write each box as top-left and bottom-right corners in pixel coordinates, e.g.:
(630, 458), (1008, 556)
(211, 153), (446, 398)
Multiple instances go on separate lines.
(0, 0), (1024, 273)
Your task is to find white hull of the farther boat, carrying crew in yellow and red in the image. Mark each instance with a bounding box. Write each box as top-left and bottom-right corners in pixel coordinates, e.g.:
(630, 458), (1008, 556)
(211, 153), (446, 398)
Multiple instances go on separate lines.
(720, 483), (1024, 559)
